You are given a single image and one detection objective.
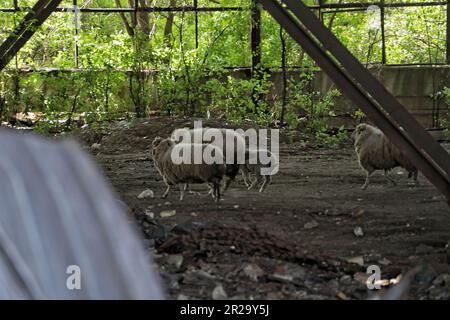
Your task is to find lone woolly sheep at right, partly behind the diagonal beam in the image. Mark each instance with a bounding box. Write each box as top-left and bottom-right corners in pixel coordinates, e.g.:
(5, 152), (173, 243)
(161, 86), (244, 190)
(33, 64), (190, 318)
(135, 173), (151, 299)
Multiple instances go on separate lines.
(352, 123), (418, 190)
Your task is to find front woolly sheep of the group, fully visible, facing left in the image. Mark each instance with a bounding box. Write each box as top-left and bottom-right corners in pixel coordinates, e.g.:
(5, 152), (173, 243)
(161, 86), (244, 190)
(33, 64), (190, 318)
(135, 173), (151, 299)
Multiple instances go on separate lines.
(151, 137), (226, 201)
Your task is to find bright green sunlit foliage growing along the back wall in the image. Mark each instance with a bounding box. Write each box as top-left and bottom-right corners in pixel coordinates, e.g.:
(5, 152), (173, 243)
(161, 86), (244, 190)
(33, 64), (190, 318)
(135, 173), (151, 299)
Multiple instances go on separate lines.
(0, 0), (448, 145)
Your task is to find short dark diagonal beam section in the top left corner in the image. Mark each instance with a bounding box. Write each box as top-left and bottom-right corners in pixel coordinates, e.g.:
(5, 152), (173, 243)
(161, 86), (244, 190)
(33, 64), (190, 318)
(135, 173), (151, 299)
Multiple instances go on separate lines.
(0, 0), (62, 71)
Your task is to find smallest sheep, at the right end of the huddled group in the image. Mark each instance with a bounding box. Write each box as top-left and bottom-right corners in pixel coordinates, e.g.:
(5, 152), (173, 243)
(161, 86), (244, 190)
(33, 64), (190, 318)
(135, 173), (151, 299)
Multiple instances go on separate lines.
(241, 148), (279, 192)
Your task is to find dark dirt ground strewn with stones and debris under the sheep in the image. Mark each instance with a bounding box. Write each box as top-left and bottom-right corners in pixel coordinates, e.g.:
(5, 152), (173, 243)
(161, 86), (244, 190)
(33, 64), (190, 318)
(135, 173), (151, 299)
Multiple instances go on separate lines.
(78, 118), (450, 299)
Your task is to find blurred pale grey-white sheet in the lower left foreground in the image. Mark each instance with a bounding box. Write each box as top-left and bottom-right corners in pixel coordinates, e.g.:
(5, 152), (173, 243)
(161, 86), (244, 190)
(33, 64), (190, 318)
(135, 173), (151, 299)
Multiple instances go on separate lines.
(0, 130), (163, 299)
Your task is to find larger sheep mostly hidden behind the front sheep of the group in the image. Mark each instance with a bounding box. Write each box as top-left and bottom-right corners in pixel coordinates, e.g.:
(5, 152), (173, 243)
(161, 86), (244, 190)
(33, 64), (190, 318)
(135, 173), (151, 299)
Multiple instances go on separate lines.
(171, 128), (245, 192)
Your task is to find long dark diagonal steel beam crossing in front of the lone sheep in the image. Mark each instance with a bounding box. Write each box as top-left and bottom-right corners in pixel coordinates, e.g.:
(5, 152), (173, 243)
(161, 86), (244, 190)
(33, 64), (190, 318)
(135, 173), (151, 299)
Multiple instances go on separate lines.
(259, 0), (450, 203)
